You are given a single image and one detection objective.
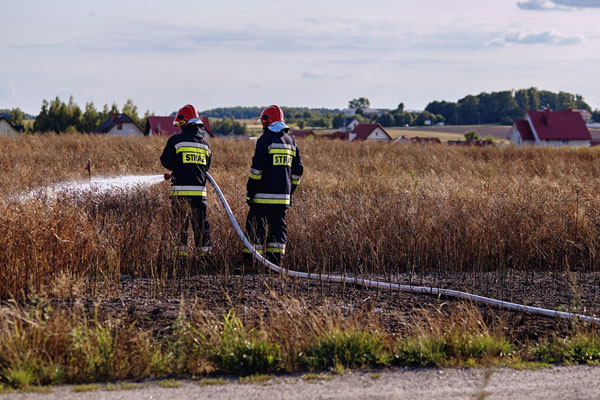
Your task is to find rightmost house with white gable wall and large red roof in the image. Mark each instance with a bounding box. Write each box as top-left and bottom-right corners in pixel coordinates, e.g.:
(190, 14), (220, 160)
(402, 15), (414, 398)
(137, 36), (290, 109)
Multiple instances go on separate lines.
(508, 109), (592, 146)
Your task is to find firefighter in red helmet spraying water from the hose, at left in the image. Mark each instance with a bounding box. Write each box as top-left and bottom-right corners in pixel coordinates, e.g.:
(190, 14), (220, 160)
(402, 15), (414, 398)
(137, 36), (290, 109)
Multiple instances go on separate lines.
(160, 104), (212, 259)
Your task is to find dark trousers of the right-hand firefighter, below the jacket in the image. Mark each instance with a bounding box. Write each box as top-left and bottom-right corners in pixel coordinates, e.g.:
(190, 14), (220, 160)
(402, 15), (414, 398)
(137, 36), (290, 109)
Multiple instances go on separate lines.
(244, 204), (287, 265)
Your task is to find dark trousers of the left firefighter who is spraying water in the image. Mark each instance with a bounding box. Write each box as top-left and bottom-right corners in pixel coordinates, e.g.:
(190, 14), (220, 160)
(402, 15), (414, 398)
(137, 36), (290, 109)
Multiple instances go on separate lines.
(171, 196), (211, 255)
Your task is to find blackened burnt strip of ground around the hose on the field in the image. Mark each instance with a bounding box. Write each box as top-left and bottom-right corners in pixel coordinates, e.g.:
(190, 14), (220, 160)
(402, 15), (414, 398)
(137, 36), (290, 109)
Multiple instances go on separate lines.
(60, 272), (600, 341)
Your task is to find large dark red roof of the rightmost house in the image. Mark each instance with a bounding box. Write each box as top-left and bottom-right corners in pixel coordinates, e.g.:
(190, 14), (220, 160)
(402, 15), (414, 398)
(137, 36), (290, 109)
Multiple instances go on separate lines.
(527, 110), (592, 140)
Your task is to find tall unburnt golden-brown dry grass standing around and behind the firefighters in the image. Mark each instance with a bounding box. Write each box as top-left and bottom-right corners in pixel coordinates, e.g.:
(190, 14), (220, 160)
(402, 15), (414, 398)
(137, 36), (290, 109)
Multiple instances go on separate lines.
(0, 135), (600, 298)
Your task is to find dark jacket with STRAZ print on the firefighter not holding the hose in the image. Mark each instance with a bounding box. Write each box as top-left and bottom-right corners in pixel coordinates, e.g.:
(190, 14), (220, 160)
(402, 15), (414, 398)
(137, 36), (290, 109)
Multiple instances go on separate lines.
(246, 130), (304, 208)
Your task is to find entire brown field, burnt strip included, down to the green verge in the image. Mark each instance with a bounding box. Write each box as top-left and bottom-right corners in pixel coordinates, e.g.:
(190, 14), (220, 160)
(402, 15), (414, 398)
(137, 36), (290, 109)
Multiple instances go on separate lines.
(0, 135), (600, 386)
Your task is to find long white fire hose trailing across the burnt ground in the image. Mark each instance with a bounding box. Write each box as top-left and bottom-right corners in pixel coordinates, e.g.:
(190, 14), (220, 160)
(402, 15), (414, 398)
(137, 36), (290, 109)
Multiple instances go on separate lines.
(206, 173), (600, 323)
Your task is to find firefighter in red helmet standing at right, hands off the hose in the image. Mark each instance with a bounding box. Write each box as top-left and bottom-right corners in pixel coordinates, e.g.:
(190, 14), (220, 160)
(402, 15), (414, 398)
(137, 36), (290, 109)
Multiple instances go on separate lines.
(244, 105), (304, 265)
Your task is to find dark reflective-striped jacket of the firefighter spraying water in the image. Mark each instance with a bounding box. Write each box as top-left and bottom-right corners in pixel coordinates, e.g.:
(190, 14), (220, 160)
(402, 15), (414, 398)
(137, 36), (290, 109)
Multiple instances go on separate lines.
(160, 125), (212, 200)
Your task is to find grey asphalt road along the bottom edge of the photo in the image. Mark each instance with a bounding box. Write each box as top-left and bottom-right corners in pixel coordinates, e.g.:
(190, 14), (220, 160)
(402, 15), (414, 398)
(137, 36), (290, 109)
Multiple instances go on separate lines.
(0, 366), (600, 400)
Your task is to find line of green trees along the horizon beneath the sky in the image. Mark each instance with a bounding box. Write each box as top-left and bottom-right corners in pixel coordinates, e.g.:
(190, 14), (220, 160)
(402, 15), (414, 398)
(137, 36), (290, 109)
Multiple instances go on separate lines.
(0, 87), (600, 135)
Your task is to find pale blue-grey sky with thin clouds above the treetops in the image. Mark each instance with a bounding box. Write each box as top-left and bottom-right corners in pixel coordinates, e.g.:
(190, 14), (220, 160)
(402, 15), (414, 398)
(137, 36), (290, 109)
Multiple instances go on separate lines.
(0, 0), (600, 115)
